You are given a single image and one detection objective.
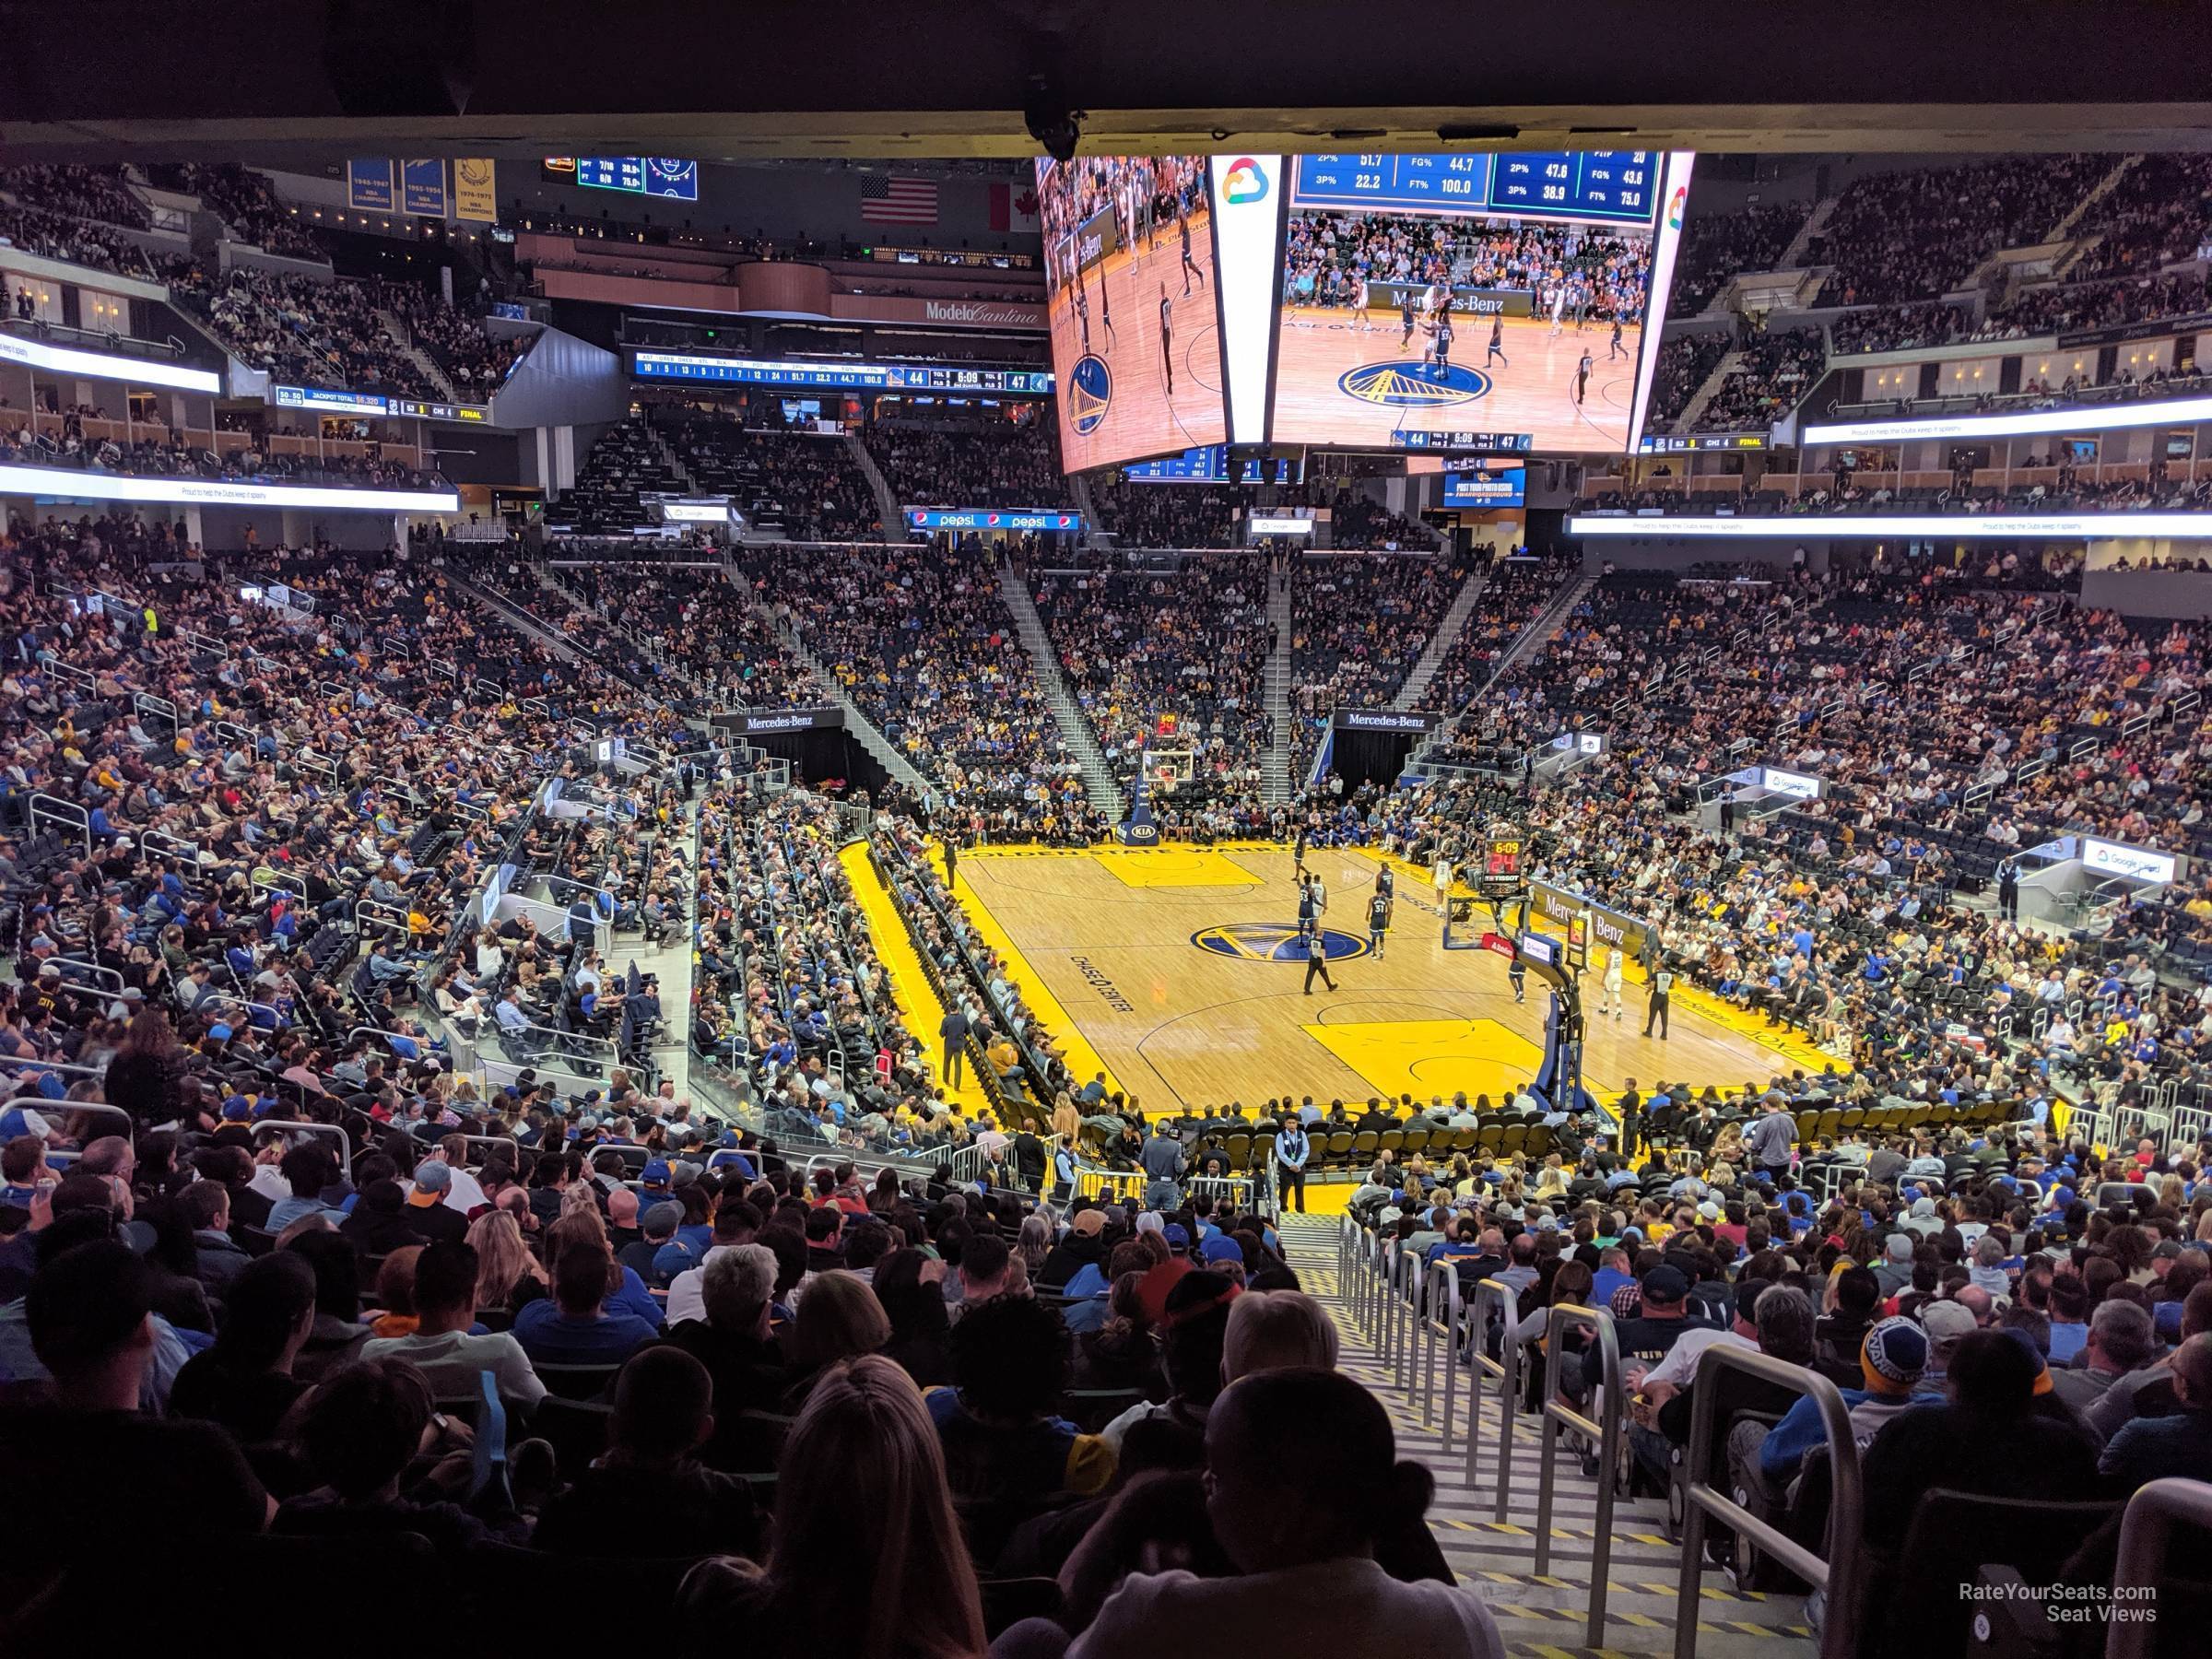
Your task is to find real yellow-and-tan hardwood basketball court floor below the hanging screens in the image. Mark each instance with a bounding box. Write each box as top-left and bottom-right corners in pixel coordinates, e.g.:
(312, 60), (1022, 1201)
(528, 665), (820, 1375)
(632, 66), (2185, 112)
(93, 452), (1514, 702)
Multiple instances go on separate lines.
(958, 842), (1823, 1112)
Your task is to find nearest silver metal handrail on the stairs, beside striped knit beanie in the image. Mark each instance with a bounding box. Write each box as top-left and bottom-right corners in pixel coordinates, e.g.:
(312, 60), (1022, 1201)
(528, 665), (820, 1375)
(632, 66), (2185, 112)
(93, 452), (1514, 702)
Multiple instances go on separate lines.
(1675, 1343), (1863, 1659)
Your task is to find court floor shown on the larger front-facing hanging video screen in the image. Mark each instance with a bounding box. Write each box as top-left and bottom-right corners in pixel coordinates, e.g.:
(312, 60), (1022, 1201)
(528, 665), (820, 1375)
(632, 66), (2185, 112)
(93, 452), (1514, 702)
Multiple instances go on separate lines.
(1274, 308), (1641, 452)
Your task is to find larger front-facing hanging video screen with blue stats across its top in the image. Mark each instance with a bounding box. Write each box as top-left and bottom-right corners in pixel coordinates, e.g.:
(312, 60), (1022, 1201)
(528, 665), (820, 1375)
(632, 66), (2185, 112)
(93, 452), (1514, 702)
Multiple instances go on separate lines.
(1267, 150), (1688, 453)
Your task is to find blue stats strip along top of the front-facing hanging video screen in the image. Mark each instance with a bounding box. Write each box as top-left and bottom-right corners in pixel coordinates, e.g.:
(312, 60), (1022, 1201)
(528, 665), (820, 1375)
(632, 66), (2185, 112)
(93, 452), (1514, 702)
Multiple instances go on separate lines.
(1289, 150), (1659, 226)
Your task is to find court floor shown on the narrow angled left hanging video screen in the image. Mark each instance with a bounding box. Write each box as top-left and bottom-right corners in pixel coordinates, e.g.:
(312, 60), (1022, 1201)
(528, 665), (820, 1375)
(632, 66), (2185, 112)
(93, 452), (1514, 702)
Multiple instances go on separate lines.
(1049, 208), (1228, 474)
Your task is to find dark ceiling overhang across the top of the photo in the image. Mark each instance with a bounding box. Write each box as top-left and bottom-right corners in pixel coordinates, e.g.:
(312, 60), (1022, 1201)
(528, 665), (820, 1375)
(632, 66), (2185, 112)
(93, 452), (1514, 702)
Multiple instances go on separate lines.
(0, 0), (2212, 164)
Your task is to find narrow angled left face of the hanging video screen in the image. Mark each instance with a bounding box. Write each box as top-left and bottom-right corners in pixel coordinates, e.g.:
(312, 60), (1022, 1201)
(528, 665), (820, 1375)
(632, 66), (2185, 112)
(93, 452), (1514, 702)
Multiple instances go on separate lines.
(1038, 155), (1228, 471)
